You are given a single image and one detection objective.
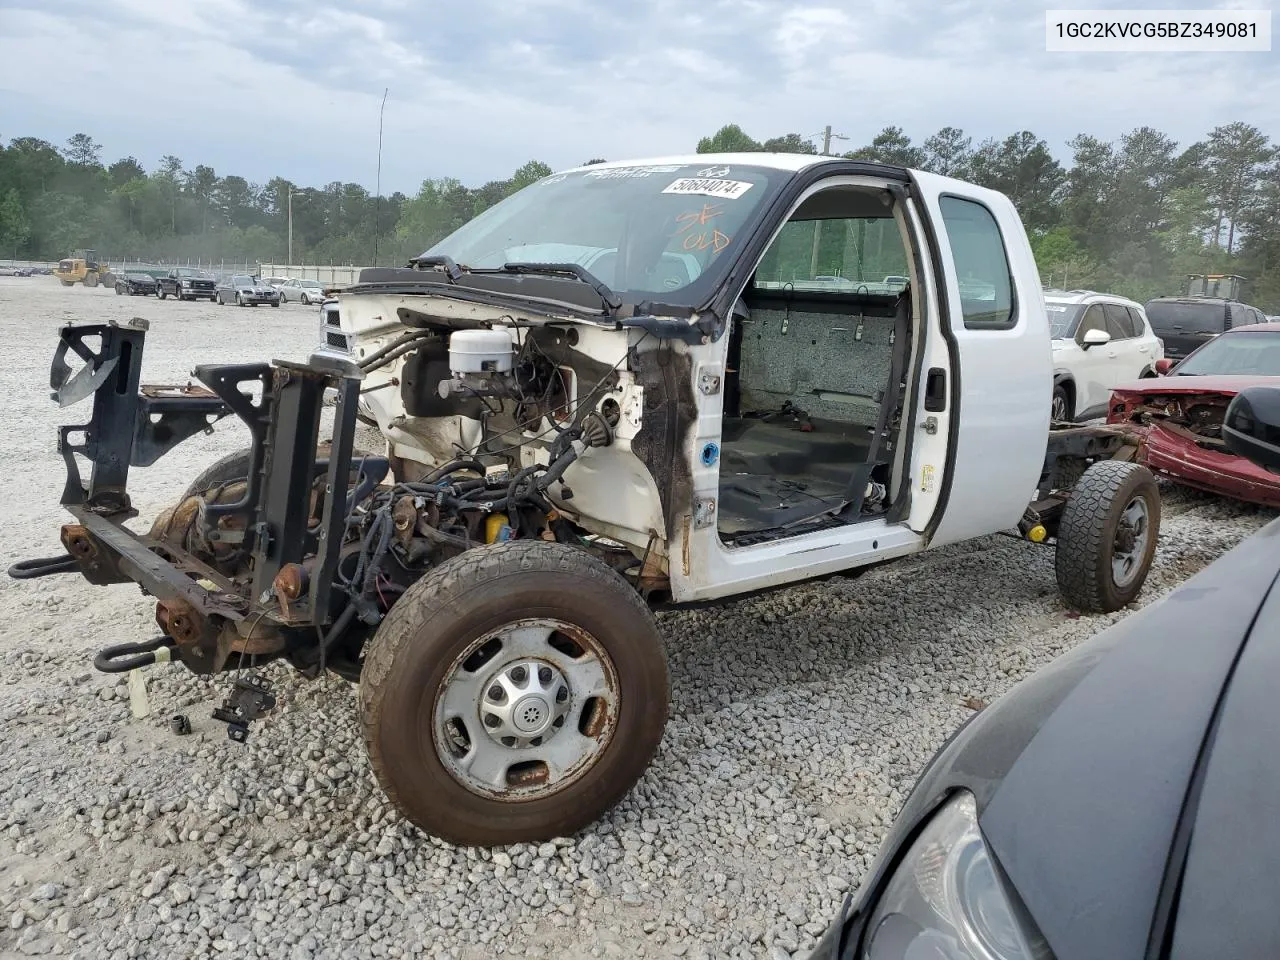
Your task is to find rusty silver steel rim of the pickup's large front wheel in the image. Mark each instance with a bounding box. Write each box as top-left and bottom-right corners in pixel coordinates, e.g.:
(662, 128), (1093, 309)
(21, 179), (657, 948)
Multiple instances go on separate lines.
(431, 618), (621, 803)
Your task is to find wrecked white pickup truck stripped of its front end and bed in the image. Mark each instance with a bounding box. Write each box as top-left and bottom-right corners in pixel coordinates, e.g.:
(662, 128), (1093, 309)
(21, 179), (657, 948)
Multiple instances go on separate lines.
(10, 154), (1160, 845)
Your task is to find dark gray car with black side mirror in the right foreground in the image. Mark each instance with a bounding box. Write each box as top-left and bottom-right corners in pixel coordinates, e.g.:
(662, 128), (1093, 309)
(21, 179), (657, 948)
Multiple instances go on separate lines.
(810, 387), (1280, 960)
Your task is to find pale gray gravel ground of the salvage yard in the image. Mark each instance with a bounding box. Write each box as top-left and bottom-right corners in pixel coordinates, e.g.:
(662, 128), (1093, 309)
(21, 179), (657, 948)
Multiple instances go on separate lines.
(0, 278), (1272, 960)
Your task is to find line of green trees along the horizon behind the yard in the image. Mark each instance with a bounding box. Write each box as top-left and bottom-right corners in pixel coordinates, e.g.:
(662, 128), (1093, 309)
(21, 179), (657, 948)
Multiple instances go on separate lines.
(0, 123), (1280, 312)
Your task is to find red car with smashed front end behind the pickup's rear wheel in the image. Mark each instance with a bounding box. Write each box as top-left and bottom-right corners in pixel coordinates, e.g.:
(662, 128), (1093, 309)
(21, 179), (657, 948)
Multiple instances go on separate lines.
(1107, 323), (1280, 507)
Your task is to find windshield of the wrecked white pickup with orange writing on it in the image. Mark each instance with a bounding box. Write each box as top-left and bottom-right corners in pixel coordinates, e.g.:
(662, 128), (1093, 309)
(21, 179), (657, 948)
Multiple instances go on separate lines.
(424, 163), (792, 306)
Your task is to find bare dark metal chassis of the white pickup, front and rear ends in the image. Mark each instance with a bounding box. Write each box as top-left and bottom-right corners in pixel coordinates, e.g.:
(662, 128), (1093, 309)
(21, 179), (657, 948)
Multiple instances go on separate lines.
(10, 320), (1137, 673)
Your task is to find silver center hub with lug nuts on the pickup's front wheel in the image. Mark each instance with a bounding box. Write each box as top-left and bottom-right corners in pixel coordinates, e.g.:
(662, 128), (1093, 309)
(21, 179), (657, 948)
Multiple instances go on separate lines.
(480, 659), (571, 748)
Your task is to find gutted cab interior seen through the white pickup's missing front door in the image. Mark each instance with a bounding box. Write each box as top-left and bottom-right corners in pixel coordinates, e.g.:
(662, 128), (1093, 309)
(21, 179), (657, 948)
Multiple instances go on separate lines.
(718, 189), (911, 544)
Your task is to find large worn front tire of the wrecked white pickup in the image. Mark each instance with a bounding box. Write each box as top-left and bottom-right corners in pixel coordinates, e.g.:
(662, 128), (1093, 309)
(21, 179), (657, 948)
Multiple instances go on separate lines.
(360, 540), (668, 846)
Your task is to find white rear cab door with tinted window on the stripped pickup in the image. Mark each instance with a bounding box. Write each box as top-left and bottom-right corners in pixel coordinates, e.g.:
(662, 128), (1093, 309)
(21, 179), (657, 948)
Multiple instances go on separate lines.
(910, 173), (1053, 545)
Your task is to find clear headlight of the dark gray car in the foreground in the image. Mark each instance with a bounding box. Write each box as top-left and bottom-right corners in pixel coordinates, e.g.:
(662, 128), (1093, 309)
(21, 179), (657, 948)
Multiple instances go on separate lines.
(863, 792), (1052, 960)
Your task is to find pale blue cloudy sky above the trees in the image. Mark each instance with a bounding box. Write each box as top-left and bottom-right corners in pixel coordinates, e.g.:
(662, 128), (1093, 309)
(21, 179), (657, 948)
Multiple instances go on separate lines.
(0, 0), (1280, 192)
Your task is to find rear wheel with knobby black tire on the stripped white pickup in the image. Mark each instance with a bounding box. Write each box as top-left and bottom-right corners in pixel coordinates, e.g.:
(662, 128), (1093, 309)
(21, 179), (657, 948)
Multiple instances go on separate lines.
(1055, 460), (1160, 613)
